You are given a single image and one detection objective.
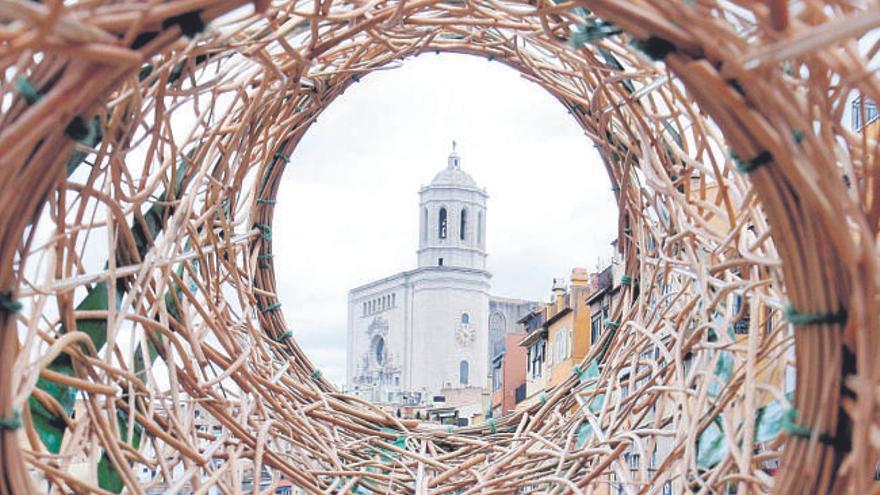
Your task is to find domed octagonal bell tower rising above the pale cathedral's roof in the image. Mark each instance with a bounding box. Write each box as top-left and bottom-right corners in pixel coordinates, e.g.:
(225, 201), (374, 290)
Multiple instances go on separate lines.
(417, 141), (488, 270)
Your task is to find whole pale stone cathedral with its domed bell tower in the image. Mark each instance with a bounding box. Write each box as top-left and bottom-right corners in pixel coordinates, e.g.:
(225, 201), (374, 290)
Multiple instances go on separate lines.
(346, 147), (535, 405)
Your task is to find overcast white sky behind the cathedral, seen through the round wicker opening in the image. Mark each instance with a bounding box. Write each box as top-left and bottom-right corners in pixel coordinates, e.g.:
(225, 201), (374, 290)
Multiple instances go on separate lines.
(273, 54), (617, 385)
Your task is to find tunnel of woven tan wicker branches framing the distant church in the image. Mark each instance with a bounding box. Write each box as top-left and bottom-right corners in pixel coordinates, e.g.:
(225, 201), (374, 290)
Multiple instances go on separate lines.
(0, 0), (880, 494)
